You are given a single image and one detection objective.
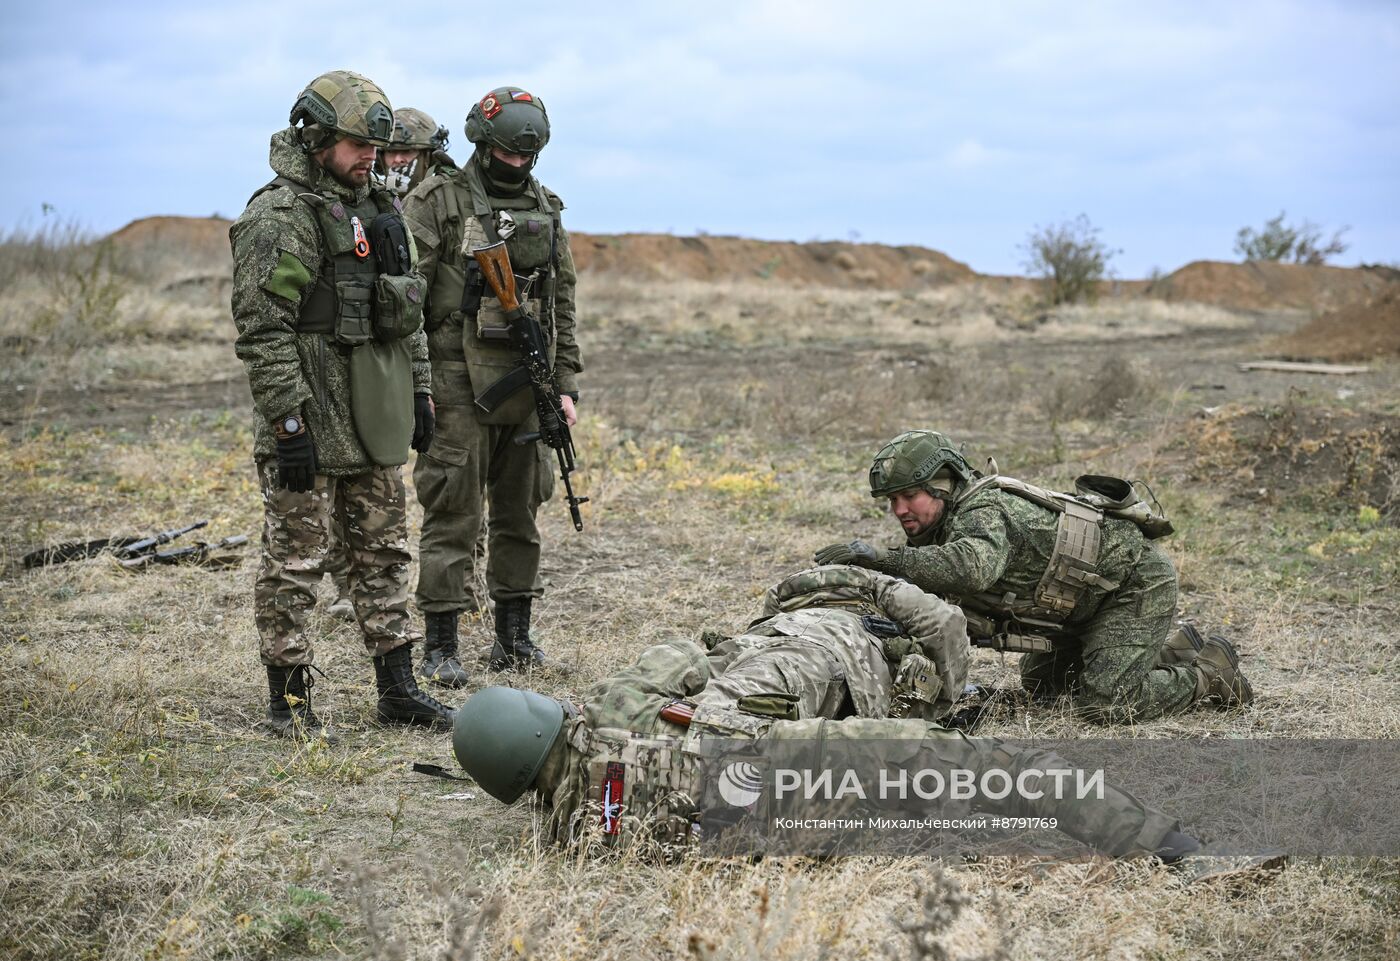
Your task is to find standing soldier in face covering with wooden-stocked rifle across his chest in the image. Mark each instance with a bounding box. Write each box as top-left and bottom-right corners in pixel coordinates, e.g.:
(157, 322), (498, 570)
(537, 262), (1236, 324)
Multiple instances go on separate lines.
(405, 87), (582, 686)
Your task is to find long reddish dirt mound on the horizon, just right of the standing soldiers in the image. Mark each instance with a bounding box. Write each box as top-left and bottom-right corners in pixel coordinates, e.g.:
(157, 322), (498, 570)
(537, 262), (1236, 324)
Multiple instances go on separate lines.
(573, 234), (977, 287)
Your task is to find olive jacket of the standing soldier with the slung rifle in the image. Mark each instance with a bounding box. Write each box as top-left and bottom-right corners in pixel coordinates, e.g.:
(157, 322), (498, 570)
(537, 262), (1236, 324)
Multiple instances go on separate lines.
(403, 160), (584, 403)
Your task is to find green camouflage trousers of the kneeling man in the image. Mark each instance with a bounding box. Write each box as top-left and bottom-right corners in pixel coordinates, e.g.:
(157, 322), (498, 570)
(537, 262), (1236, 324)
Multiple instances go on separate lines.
(1021, 542), (1196, 724)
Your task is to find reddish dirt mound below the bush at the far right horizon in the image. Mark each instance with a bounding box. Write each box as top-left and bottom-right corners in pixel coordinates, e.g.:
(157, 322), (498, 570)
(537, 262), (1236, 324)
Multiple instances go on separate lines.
(1144, 261), (1390, 310)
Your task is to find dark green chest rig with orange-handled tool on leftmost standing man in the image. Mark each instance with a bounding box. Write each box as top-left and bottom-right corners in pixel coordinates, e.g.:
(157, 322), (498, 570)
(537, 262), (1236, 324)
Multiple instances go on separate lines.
(253, 177), (402, 347)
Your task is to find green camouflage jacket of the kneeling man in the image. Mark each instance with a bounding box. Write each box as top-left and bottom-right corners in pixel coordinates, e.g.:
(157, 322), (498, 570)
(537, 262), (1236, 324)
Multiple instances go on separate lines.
(876, 488), (1147, 625)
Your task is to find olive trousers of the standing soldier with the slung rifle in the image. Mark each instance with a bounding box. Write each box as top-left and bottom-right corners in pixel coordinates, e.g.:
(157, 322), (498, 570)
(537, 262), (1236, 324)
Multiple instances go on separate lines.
(413, 392), (553, 614)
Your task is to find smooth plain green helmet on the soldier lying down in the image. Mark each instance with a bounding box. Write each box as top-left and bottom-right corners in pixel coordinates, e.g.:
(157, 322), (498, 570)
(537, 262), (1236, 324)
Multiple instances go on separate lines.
(452, 688), (564, 804)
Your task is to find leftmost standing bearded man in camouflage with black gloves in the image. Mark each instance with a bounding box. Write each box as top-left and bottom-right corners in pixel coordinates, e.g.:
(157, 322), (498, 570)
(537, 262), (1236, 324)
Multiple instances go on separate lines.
(230, 70), (451, 734)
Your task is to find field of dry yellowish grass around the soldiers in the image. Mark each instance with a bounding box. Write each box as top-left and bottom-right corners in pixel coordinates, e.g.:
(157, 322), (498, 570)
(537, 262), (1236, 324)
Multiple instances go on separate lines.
(0, 231), (1400, 961)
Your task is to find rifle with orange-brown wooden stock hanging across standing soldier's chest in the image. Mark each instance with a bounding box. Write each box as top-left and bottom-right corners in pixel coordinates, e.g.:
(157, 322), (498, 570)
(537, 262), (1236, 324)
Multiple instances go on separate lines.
(472, 241), (588, 531)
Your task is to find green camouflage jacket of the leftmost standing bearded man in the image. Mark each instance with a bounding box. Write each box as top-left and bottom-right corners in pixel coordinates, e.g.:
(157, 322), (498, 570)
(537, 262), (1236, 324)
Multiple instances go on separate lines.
(228, 127), (433, 475)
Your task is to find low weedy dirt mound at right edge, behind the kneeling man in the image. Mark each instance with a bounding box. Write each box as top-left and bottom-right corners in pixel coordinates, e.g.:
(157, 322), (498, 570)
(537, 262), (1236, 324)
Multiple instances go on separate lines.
(1187, 402), (1400, 521)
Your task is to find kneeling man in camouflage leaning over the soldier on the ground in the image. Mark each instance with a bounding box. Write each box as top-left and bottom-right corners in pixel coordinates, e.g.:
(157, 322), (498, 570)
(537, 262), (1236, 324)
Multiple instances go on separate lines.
(816, 430), (1253, 723)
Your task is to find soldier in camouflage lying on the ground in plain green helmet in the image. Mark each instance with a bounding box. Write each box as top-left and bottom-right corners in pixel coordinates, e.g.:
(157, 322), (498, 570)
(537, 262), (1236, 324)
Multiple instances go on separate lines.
(452, 566), (1282, 876)
